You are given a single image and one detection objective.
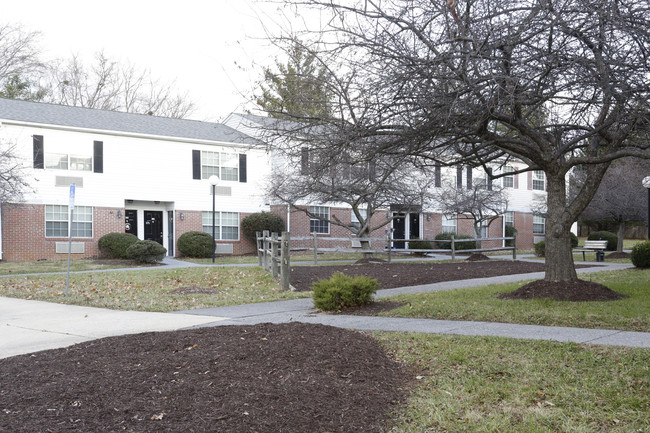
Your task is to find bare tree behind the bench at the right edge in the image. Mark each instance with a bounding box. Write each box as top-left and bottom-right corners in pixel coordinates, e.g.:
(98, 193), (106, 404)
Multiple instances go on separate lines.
(580, 158), (650, 252)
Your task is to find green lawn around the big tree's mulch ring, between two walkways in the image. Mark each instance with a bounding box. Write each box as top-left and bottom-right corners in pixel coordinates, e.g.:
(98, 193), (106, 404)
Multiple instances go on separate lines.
(374, 269), (650, 332)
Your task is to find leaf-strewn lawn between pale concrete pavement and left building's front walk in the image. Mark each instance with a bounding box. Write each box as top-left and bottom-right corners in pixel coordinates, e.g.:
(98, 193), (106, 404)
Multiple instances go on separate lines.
(0, 267), (310, 311)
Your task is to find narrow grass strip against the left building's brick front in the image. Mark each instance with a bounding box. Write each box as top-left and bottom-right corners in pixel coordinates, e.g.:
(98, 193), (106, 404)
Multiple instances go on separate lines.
(0, 259), (137, 275)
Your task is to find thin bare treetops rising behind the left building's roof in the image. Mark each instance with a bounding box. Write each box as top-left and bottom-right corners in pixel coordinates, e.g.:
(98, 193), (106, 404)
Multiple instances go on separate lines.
(49, 52), (194, 118)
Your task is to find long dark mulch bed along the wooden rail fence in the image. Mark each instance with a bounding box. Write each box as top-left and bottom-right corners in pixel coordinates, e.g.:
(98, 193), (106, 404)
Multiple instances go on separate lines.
(291, 260), (545, 291)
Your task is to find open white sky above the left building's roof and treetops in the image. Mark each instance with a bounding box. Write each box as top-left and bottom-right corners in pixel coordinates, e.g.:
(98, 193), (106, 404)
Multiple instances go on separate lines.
(0, 0), (312, 121)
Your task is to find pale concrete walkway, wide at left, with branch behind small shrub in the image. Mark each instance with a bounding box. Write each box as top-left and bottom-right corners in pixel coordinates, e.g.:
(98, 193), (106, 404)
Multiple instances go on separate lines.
(0, 262), (650, 358)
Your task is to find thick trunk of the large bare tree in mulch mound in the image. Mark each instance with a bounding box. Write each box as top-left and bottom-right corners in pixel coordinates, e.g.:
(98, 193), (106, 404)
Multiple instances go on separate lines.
(544, 176), (578, 281)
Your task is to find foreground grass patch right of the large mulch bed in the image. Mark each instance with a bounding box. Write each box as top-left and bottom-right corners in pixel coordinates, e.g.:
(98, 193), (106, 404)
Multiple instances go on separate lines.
(374, 333), (650, 433)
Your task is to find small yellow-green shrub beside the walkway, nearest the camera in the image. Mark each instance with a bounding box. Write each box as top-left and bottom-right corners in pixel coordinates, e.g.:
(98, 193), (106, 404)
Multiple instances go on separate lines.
(312, 272), (377, 311)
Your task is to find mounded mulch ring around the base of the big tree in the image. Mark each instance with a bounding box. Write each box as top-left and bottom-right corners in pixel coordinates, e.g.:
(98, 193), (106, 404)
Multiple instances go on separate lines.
(499, 280), (626, 302)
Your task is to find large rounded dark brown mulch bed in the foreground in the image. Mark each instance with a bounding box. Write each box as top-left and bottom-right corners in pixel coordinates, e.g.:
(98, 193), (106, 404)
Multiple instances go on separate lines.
(0, 323), (406, 433)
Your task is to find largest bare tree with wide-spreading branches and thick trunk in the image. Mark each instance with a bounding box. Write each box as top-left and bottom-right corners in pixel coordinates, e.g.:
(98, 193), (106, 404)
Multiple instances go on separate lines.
(266, 0), (650, 281)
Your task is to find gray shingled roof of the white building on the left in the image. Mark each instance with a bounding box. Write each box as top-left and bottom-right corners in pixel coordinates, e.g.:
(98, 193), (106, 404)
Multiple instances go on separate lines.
(0, 98), (261, 145)
